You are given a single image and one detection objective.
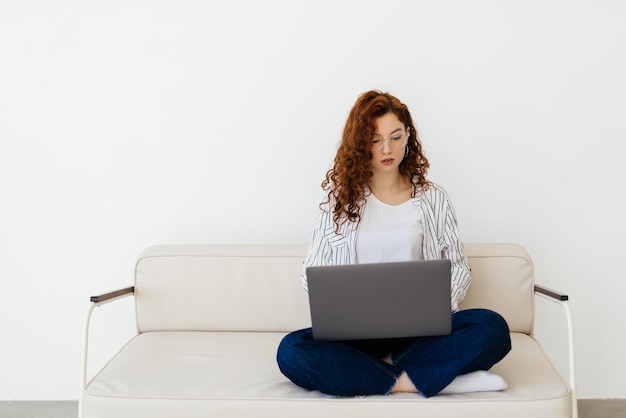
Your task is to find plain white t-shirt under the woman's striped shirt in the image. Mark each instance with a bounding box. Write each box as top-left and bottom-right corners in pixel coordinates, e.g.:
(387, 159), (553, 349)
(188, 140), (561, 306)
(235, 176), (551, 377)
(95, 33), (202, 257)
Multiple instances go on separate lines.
(356, 194), (424, 263)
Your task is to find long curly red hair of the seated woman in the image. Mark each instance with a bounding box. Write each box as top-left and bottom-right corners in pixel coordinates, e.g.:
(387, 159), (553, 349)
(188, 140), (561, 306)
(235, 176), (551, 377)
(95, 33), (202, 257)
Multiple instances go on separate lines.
(322, 90), (429, 231)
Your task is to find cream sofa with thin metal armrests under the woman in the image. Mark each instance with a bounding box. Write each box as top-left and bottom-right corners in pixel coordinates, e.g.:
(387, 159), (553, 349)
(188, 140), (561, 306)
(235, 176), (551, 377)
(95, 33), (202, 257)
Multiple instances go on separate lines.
(79, 244), (577, 418)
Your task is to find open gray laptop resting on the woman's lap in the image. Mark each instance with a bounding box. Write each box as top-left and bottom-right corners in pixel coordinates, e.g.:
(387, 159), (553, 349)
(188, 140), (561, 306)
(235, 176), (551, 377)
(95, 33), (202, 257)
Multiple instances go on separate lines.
(306, 260), (451, 340)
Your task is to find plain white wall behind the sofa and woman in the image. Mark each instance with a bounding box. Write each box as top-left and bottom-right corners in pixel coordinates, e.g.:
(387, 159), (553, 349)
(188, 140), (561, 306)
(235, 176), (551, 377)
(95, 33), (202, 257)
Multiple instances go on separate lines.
(0, 0), (626, 400)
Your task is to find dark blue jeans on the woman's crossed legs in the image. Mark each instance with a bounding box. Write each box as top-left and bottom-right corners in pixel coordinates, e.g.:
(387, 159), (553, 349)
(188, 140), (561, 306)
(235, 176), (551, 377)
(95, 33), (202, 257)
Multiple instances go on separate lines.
(277, 309), (511, 397)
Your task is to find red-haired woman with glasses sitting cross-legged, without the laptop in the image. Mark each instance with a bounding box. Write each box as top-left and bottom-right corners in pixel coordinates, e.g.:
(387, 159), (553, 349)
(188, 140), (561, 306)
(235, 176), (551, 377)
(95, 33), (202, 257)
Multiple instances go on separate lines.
(277, 91), (511, 397)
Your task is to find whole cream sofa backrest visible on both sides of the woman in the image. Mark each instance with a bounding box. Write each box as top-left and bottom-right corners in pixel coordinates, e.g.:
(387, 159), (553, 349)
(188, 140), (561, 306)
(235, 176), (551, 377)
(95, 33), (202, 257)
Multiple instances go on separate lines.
(135, 244), (534, 333)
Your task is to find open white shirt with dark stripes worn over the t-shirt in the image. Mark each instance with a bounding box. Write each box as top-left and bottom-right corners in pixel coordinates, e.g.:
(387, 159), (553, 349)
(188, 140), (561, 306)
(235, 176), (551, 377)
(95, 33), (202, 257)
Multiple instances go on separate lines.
(300, 183), (472, 312)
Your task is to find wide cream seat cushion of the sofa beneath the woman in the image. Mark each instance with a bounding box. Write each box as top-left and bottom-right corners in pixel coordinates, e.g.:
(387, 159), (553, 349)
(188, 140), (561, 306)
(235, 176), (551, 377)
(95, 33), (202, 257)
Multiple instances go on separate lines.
(83, 331), (571, 418)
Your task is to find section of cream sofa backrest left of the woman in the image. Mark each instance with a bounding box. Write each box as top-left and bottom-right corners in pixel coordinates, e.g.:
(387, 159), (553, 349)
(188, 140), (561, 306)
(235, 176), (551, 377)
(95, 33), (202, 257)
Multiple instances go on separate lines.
(135, 245), (311, 332)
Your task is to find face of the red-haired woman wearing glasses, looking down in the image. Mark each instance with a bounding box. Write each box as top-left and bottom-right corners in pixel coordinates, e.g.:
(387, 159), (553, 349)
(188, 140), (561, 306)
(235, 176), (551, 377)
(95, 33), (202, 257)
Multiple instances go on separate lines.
(370, 113), (408, 174)
